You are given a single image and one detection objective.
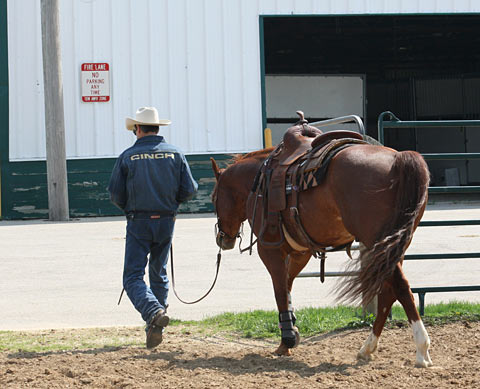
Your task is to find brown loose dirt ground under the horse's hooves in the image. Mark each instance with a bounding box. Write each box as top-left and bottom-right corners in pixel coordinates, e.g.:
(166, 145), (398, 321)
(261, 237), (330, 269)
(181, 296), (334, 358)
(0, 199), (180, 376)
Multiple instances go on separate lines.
(0, 322), (480, 388)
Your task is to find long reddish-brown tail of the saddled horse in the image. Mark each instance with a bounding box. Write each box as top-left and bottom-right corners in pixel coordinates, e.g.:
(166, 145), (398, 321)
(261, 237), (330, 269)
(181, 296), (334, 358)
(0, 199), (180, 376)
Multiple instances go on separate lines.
(339, 151), (430, 305)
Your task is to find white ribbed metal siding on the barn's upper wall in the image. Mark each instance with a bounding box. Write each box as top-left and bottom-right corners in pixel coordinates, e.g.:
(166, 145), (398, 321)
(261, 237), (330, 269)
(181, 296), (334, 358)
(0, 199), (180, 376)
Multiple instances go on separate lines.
(8, 0), (480, 160)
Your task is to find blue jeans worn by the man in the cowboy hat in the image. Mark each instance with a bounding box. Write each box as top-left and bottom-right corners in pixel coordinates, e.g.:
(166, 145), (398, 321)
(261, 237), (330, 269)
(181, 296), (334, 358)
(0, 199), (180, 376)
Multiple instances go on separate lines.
(123, 216), (175, 324)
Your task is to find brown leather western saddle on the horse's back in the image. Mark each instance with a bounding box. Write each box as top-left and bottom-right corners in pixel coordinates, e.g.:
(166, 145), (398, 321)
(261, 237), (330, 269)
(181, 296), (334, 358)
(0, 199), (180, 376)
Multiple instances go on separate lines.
(252, 111), (367, 264)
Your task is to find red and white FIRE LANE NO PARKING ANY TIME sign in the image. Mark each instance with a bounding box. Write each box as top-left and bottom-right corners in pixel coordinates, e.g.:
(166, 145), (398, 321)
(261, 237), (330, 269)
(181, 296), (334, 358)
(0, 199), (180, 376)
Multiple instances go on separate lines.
(82, 63), (110, 102)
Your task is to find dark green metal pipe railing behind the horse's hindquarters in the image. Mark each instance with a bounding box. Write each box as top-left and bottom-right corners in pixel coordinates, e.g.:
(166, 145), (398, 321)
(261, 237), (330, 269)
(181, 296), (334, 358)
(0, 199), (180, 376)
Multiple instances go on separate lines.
(378, 111), (480, 316)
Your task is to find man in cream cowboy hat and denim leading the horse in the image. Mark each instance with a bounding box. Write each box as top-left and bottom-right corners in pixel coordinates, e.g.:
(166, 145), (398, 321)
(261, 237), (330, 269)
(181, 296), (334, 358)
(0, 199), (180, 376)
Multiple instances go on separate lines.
(108, 107), (198, 348)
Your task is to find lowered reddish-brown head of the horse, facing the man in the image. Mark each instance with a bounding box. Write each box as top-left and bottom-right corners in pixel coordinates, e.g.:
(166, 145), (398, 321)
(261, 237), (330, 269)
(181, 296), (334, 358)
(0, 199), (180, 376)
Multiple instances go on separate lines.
(210, 158), (246, 250)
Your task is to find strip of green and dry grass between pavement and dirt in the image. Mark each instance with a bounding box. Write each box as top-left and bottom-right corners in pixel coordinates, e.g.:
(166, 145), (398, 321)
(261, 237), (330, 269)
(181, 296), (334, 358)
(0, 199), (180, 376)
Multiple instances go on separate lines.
(0, 302), (480, 355)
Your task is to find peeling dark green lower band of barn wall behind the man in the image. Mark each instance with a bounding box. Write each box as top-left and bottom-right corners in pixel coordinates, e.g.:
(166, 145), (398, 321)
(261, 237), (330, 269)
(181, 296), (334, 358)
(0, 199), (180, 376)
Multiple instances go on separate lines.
(2, 154), (231, 219)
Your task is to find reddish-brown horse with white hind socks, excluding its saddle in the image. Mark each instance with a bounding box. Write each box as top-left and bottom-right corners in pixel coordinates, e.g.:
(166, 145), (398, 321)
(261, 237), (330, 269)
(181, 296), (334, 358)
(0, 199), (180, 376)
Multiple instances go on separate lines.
(211, 119), (433, 367)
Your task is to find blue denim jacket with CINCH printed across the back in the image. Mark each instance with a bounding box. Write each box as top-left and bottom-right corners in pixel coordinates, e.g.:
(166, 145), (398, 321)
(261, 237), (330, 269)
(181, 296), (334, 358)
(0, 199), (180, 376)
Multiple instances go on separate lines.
(108, 135), (198, 214)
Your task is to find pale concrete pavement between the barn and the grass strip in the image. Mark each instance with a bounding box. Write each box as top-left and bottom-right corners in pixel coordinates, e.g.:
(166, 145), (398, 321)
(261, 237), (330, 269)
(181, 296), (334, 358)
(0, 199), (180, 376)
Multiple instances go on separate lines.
(0, 202), (480, 330)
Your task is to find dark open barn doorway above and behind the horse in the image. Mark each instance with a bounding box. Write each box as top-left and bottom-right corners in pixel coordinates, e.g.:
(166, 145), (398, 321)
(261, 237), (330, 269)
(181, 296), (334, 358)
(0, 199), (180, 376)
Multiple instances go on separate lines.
(263, 14), (480, 185)
